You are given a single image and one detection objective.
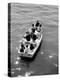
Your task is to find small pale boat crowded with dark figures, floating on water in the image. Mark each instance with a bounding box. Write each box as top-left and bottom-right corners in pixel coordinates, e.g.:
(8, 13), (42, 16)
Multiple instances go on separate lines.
(18, 21), (42, 58)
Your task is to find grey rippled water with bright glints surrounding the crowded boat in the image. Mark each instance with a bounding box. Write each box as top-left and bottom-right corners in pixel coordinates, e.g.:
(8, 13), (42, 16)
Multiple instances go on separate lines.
(11, 4), (58, 76)
